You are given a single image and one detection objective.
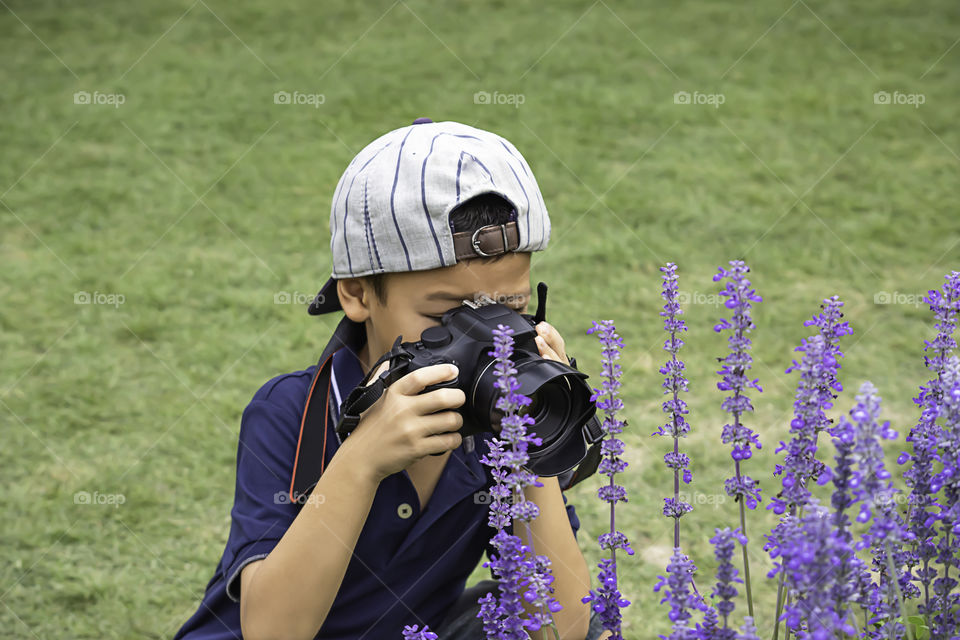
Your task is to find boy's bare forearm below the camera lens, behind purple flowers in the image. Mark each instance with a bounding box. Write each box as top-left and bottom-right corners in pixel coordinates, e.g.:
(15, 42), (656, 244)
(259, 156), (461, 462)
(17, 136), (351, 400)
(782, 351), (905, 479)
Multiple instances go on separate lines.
(513, 477), (590, 640)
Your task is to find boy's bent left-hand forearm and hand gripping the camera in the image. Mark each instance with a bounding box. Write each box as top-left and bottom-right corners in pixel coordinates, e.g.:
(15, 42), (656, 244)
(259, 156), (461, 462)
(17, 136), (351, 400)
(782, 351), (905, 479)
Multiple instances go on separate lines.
(240, 362), (466, 640)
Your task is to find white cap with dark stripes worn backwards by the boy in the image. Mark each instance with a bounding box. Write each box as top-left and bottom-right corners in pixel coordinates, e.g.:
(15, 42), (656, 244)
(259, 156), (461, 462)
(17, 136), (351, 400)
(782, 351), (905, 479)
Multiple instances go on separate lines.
(308, 118), (550, 315)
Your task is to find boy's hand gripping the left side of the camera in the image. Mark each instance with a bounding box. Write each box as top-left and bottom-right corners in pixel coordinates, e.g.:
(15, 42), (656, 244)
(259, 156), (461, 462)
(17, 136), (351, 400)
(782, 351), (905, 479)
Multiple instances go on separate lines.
(341, 361), (467, 483)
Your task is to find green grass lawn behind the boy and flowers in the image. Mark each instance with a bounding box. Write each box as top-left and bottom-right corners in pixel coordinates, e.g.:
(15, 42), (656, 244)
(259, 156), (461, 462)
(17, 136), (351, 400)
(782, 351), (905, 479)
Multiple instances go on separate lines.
(0, 0), (960, 638)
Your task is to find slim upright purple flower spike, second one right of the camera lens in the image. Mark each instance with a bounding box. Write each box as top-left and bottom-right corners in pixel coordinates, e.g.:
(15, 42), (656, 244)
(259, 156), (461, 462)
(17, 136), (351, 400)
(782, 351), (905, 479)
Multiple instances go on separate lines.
(652, 262), (693, 547)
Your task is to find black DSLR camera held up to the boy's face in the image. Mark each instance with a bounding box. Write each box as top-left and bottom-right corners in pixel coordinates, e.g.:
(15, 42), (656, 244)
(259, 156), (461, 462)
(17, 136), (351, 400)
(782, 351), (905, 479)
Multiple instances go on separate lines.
(336, 282), (603, 477)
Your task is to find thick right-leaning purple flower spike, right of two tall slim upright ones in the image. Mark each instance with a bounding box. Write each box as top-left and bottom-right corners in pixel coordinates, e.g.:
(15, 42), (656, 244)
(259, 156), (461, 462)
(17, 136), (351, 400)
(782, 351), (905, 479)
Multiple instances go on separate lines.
(767, 296), (852, 514)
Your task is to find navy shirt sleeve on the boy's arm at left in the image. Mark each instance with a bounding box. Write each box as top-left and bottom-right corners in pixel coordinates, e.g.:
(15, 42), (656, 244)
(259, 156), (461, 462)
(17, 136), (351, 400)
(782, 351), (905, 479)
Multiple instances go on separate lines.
(221, 394), (300, 602)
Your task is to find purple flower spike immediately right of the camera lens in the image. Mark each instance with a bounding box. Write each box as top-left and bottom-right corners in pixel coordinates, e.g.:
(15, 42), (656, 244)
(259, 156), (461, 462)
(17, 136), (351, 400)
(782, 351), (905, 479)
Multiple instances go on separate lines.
(582, 320), (633, 640)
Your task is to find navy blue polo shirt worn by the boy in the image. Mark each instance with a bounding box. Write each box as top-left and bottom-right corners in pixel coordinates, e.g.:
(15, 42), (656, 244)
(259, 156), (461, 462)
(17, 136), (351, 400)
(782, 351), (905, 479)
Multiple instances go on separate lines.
(174, 317), (580, 640)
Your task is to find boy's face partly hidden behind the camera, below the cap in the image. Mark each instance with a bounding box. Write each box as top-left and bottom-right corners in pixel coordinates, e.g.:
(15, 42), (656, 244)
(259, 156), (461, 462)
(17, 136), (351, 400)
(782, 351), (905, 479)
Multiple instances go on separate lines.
(339, 253), (531, 373)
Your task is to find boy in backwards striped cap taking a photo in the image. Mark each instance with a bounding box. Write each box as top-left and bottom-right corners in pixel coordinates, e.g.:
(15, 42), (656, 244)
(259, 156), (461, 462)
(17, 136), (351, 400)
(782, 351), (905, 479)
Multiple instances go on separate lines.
(175, 118), (600, 640)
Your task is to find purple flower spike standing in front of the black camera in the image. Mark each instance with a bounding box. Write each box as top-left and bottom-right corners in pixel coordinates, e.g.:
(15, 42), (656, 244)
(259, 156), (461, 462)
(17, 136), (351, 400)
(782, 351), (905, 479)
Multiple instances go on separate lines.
(477, 324), (562, 640)
